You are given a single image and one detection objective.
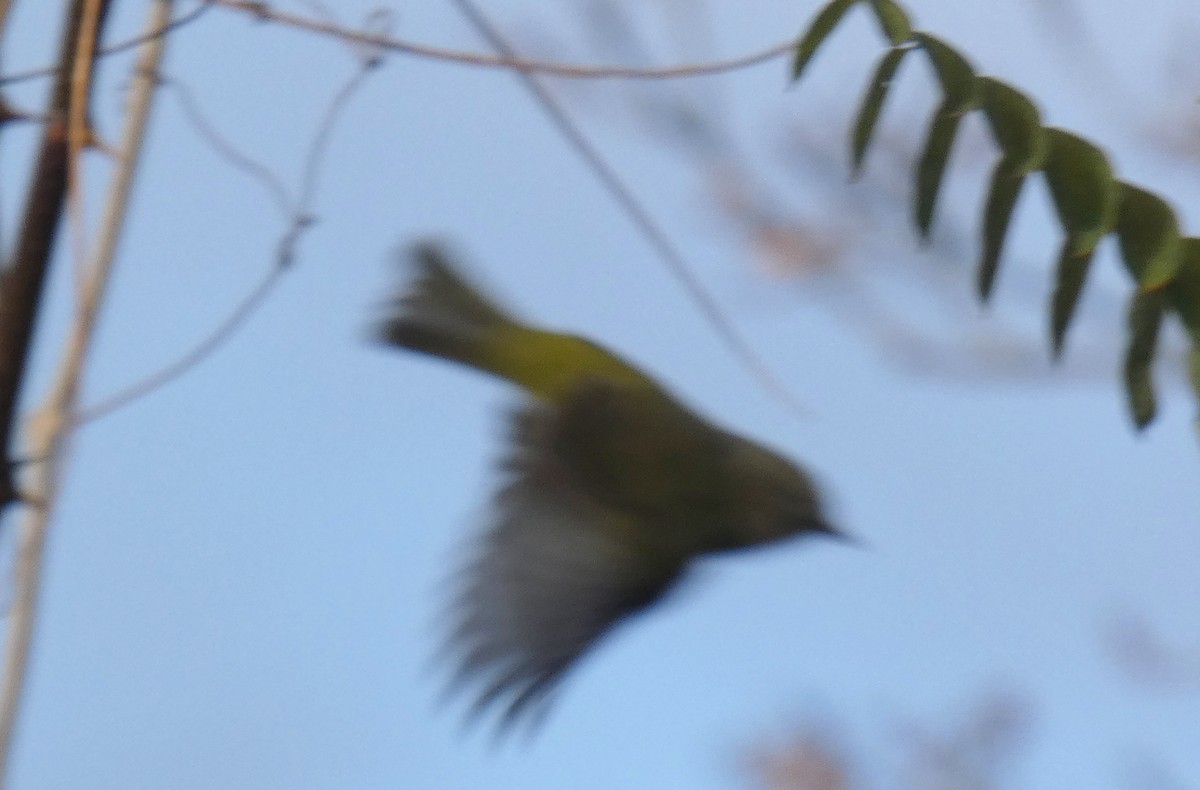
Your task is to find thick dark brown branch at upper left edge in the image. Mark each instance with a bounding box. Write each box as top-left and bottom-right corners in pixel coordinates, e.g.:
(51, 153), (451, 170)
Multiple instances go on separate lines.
(0, 0), (110, 509)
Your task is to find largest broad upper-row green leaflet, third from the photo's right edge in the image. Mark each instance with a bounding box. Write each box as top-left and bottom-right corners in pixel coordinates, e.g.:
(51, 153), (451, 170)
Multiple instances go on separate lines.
(1044, 126), (1118, 255)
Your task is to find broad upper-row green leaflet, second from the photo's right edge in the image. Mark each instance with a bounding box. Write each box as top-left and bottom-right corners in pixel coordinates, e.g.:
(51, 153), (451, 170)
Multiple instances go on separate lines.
(1116, 181), (1180, 289)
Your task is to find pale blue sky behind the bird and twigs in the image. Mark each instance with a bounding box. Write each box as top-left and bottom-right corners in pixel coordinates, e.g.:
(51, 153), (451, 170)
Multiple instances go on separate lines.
(0, 0), (1200, 790)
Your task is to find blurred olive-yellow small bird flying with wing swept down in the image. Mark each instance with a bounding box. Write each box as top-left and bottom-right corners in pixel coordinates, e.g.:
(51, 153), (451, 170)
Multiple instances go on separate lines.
(378, 243), (841, 728)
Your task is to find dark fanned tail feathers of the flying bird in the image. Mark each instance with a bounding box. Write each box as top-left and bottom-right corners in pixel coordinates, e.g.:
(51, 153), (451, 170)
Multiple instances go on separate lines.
(378, 243), (520, 375)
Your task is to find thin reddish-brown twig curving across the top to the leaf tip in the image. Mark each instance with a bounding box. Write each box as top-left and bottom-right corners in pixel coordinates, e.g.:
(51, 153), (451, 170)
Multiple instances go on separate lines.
(205, 0), (796, 79)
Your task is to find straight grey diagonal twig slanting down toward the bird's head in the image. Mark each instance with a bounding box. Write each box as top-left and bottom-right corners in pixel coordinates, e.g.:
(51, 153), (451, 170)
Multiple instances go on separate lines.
(454, 0), (808, 415)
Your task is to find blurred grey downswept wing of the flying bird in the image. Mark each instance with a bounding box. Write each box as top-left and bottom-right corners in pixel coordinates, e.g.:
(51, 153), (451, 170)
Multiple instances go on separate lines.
(449, 405), (686, 726)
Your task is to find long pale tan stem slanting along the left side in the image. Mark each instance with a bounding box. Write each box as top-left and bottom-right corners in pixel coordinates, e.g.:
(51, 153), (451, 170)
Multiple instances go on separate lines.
(0, 0), (170, 782)
